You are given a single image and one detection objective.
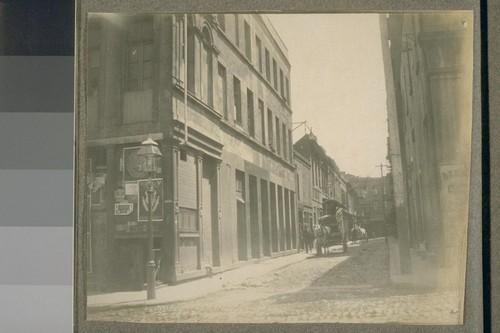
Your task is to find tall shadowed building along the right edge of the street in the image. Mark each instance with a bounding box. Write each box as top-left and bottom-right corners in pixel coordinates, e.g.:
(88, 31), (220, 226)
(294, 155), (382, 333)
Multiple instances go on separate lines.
(380, 12), (473, 268)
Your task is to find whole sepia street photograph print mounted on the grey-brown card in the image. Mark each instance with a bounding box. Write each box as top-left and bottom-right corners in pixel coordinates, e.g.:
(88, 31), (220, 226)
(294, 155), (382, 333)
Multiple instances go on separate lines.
(81, 11), (474, 325)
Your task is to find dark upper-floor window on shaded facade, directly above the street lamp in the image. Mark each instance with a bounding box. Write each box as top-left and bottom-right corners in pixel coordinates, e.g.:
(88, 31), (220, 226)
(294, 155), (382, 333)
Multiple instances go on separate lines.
(125, 19), (153, 91)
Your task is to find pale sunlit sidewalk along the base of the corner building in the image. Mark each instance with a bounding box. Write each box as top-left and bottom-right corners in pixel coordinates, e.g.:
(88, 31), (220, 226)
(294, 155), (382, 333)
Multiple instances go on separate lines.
(87, 252), (313, 311)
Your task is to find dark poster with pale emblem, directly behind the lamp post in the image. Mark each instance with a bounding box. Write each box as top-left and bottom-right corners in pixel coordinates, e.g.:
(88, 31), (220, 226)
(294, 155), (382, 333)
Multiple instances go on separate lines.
(137, 179), (163, 221)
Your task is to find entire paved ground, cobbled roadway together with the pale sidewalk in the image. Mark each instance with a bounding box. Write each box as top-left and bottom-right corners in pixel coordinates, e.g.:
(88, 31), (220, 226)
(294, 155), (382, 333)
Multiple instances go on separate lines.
(88, 238), (462, 324)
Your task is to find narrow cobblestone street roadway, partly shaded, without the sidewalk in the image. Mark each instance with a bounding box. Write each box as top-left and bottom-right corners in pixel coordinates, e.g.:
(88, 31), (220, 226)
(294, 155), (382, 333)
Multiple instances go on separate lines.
(88, 239), (459, 324)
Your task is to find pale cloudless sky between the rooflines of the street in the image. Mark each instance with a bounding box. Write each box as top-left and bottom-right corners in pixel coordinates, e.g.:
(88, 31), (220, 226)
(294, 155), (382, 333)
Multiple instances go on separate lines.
(267, 14), (388, 177)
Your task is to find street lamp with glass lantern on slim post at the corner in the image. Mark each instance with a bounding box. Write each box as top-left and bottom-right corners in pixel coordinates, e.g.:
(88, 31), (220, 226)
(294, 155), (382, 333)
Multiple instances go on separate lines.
(137, 137), (162, 299)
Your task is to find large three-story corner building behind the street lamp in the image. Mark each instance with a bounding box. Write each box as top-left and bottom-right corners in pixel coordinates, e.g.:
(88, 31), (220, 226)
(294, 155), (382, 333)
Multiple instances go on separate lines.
(86, 14), (297, 289)
